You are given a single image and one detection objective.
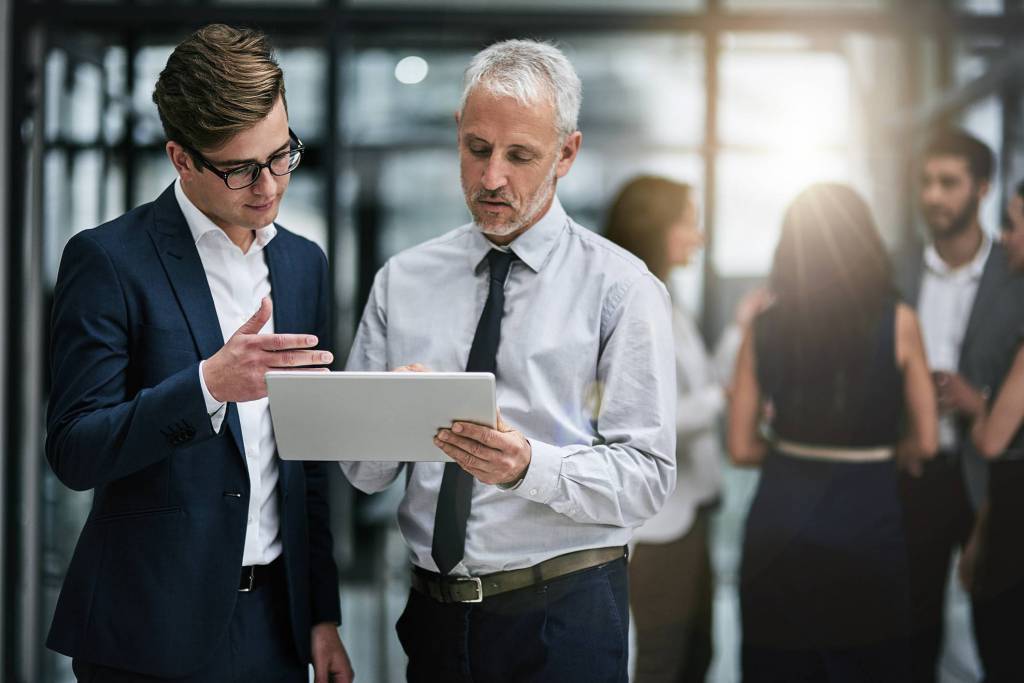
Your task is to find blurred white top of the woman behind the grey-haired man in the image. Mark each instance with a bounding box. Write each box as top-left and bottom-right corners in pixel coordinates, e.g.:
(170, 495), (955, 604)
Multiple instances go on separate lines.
(633, 302), (742, 544)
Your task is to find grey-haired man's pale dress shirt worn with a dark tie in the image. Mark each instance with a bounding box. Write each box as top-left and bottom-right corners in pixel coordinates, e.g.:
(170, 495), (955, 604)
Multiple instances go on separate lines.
(342, 199), (676, 575)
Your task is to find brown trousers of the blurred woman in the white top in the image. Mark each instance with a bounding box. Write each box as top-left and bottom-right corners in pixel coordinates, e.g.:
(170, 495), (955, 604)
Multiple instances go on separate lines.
(630, 508), (714, 683)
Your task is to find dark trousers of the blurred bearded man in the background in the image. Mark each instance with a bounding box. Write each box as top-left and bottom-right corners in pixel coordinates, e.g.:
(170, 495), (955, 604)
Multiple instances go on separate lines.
(900, 454), (974, 683)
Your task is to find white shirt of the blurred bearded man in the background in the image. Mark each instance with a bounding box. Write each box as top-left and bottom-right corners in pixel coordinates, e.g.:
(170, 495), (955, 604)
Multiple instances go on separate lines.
(918, 234), (992, 451)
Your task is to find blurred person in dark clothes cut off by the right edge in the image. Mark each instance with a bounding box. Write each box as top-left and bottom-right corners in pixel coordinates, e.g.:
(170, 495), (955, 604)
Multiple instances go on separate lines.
(939, 183), (1024, 683)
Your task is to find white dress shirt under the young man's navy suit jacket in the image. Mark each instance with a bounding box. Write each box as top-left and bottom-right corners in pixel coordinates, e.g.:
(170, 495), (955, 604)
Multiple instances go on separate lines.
(174, 180), (282, 565)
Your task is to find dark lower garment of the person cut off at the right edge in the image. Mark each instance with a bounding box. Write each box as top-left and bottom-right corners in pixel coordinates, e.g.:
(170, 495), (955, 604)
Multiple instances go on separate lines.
(971, 460), (1024, 683)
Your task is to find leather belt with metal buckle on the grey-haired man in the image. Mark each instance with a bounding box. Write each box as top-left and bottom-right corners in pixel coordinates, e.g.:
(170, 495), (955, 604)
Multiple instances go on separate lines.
(413, 546), (628, 602)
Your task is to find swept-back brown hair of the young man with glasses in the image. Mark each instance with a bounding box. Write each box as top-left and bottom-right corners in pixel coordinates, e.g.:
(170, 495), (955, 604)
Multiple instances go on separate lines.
(153, 24), (287, 151)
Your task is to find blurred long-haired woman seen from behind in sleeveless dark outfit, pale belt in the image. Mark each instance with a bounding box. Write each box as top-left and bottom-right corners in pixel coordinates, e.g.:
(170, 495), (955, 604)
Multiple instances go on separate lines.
(728, 184), (937, 682)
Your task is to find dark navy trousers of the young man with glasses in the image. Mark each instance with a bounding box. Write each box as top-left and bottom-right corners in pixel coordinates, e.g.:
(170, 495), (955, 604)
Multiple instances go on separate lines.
(72, 562), (309, 683)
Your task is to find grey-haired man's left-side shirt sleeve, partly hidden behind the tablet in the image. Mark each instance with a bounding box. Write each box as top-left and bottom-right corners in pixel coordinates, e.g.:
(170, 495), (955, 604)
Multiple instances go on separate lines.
(338, 264), (404, 494)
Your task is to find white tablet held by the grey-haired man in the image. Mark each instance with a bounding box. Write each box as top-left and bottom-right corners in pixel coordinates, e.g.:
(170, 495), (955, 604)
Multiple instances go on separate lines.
(266, 372), (498, 462)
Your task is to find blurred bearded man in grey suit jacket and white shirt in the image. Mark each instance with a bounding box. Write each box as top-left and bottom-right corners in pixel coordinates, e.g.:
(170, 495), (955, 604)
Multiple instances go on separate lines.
(896, 130), (1024, 682)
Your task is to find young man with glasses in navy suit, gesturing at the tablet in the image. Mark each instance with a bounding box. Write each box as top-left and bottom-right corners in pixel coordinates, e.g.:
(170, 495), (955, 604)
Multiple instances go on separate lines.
(46, 25), (352, 683)
